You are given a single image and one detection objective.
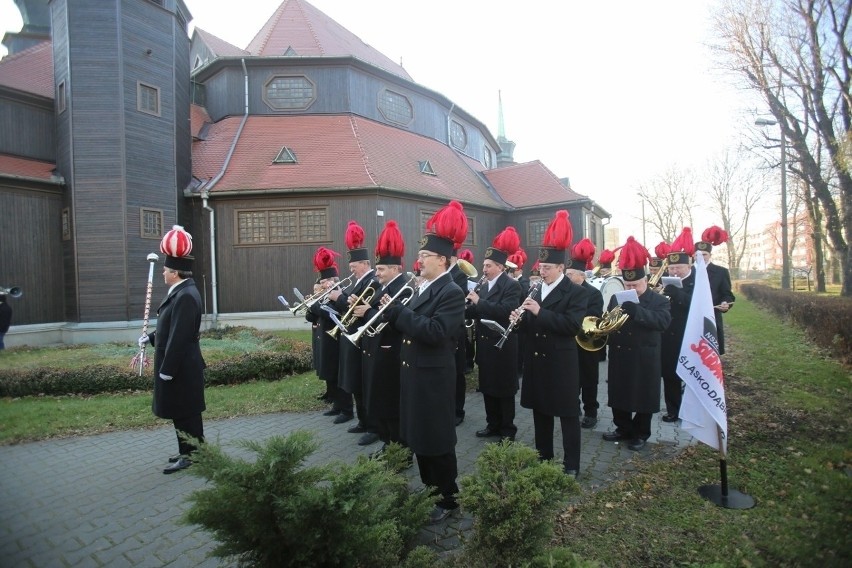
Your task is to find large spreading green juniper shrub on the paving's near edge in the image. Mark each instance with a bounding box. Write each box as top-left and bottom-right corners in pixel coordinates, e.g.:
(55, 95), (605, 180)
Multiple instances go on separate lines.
(184, 431), (434, 568)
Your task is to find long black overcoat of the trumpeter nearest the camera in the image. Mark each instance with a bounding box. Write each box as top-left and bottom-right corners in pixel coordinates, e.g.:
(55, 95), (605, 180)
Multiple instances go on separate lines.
(385, 274), (467, 456)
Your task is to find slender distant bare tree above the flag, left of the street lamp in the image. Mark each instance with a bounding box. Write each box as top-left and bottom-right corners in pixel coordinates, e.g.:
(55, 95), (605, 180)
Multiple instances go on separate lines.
(696, 150), (768, 278)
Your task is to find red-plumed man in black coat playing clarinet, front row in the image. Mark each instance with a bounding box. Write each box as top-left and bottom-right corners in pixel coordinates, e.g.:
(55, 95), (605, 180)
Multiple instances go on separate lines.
(512, 209), (587, 477)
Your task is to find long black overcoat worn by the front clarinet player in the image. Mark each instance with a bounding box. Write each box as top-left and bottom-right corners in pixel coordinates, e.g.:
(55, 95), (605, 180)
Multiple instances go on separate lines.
(518, 277), (587, 416)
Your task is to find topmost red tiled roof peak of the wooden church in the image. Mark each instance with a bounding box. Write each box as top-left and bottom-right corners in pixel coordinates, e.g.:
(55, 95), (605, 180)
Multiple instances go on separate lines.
(246, 0), (412, 81)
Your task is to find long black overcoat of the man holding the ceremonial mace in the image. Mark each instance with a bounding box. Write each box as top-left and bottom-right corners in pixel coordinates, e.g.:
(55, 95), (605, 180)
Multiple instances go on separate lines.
(148, 278), (207, 419)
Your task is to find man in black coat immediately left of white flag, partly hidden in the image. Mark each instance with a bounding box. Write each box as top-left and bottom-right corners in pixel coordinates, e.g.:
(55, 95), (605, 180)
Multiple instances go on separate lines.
(660, 252), (695, 422)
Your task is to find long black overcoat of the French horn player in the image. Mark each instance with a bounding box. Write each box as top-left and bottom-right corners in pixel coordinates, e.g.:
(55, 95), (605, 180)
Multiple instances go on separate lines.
(607, 288), (672, 414)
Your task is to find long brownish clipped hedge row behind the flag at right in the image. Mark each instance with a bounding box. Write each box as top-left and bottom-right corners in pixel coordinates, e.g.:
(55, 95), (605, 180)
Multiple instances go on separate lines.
(739, 284), (852, 364)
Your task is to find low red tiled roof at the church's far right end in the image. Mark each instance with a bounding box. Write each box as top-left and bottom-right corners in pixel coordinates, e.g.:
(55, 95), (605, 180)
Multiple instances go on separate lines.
(482, 160), (586, 208)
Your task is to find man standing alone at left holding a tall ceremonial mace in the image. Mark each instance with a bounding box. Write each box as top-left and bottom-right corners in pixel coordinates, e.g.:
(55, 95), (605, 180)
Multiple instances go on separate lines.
(139, 237), (207, 474)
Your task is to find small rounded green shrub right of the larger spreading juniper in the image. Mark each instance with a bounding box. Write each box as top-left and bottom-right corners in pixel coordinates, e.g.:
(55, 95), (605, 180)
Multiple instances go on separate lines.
(459, 442), (578, 568)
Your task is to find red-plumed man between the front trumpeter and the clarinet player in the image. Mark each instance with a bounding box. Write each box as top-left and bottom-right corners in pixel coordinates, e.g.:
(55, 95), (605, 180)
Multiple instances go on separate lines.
(465, 227), (522, 440)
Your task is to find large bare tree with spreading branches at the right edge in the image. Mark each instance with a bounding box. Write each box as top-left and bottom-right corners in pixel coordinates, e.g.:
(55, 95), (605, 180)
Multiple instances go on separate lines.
(716, 0), (852, 296)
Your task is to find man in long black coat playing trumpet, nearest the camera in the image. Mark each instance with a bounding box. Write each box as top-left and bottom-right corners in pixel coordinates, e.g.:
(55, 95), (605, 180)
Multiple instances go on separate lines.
(384, 223), (467, 523)
